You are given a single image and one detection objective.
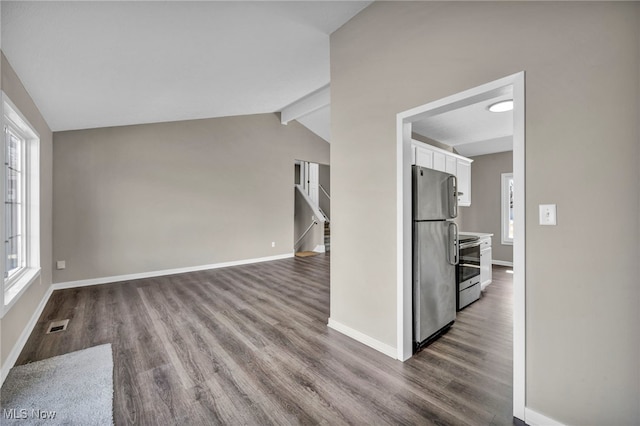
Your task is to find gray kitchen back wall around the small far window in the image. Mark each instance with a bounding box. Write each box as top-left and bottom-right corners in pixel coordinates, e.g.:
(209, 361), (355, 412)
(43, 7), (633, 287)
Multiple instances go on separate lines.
(458, 151), (513, 262)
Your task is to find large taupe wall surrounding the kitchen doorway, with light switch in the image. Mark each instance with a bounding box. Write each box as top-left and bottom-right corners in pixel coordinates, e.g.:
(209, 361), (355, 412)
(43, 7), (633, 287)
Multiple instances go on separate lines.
(331, 2), (640, 425)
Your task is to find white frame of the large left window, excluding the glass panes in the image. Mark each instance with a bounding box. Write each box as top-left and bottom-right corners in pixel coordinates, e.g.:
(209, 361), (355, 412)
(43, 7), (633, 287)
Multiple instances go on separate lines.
(0, 92), (41, 318)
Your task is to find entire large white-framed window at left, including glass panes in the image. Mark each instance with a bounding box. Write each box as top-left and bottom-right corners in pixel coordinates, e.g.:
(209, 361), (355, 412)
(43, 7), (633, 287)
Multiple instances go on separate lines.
(0, 93), (40, 317)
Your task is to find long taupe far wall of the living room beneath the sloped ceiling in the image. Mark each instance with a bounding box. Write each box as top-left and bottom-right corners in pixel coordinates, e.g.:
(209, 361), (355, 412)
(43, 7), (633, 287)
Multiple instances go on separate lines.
(53, 114), (329, 282)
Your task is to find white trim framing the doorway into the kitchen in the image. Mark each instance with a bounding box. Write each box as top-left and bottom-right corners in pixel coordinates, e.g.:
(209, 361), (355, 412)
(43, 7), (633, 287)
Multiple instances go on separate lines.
(396, 72), (525, 419)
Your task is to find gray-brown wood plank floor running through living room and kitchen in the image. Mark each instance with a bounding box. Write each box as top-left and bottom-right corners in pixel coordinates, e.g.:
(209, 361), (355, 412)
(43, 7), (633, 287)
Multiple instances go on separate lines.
(18, 255), (512, 425)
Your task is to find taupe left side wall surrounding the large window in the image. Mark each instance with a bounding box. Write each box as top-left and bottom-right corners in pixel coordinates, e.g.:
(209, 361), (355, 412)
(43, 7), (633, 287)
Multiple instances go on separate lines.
(0, 50), (52, 369)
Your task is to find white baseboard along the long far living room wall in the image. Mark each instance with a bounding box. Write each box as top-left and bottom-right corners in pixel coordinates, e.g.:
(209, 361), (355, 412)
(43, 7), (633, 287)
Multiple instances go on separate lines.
(53, 253), (294, 290)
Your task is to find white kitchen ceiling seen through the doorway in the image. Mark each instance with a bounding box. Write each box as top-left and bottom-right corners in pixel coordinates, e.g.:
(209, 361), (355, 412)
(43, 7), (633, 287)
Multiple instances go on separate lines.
(412, 93), (513, 157)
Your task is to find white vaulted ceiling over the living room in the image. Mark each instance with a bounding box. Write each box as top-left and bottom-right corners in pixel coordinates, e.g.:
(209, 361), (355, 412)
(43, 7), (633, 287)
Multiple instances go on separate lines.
(1, 1), (371, 131)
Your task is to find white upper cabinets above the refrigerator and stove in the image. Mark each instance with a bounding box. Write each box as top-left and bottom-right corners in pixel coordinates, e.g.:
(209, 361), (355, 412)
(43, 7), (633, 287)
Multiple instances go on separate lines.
(411, 140), (473, 207)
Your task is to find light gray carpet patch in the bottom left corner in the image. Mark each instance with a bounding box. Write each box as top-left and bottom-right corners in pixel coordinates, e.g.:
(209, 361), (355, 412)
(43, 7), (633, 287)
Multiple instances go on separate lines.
(0, 344), (113, 425)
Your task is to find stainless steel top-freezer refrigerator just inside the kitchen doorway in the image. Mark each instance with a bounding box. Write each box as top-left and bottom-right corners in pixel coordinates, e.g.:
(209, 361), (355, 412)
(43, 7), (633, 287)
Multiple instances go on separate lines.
(412, 166), (458, 352)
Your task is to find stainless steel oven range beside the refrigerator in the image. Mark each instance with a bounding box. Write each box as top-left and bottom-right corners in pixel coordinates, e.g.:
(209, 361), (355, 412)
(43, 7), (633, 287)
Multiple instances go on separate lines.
(456, 234), (481, 310)
